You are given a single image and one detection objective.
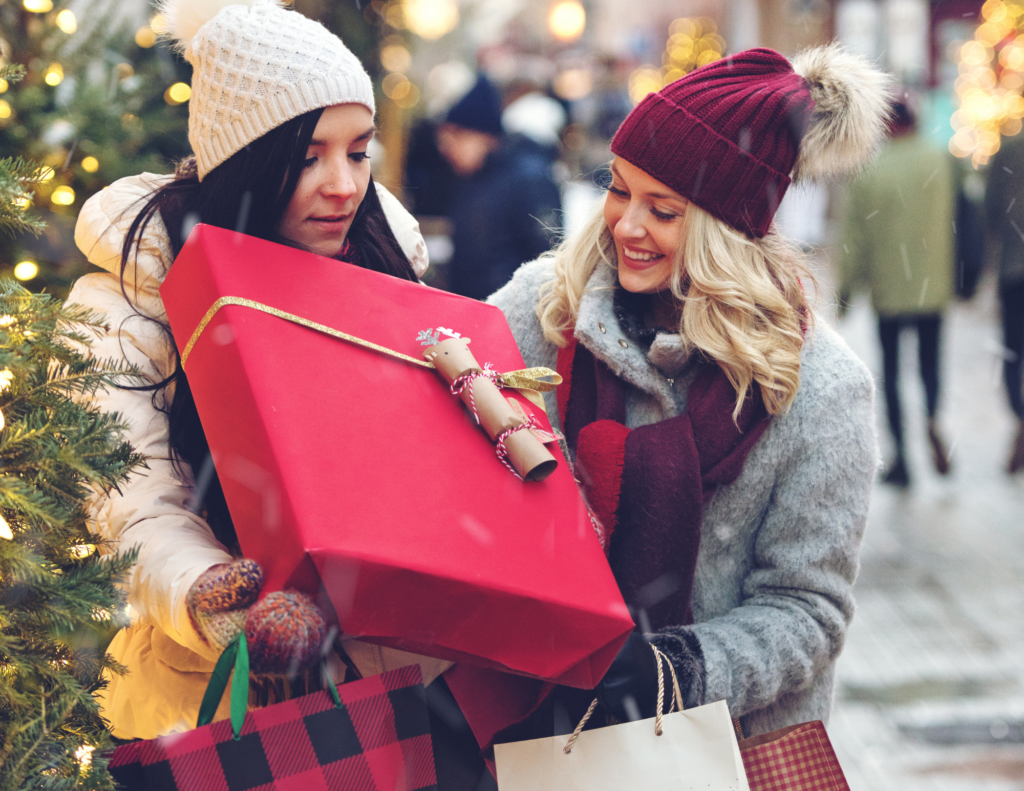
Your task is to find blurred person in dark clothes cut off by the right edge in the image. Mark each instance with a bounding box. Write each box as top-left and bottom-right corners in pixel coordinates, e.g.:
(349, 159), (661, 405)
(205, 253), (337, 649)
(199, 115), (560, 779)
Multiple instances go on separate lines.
(985, 135), (1024, 472)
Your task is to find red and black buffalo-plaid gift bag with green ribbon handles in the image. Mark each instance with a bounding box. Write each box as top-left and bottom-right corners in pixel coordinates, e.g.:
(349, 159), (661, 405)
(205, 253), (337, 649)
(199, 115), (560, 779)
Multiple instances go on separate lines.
(110, 634), (437, 791)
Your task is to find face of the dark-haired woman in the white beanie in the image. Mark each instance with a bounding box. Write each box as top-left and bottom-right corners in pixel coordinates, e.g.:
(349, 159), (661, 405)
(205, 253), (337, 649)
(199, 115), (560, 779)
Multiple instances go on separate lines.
(278, 105), (374, 258)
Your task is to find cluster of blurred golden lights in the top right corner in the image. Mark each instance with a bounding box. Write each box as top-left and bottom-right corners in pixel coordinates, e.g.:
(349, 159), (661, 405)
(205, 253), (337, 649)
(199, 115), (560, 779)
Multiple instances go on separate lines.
(949, 0), (1024, 167)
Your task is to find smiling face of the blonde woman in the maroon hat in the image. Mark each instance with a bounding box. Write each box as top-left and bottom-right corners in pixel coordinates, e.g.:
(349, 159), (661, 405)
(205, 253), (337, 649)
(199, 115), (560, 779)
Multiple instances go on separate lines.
(604, 157), (689, 294)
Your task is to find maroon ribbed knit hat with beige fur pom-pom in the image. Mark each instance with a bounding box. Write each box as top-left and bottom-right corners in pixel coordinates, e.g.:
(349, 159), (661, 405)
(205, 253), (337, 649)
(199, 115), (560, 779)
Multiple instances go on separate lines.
(611, 44), (890, 238)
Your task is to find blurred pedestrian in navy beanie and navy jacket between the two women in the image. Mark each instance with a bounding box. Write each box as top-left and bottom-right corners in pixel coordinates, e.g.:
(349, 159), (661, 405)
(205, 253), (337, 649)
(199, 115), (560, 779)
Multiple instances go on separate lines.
(437, 75), (561, 299)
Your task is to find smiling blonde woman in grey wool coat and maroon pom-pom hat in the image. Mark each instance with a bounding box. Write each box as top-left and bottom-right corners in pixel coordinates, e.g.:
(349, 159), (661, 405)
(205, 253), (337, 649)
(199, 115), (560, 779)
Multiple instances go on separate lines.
(490, 45), (888, 741)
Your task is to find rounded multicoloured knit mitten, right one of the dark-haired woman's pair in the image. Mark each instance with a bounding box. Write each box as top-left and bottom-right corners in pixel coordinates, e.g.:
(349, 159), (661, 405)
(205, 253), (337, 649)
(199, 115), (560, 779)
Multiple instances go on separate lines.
(245, 590), (327, 677)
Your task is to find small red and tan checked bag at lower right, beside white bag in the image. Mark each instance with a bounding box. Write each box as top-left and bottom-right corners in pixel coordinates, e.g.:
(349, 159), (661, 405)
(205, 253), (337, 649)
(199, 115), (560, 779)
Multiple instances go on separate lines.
(739, 720), (850, 791)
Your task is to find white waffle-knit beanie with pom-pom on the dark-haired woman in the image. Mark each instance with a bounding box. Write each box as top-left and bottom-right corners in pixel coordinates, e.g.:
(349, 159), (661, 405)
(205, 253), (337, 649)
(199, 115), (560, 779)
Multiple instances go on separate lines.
(160, 0), (376, 180)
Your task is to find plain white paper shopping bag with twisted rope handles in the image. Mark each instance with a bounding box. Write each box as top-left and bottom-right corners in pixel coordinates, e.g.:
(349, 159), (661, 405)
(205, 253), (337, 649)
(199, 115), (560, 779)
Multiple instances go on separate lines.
(495, 652), (750, 791)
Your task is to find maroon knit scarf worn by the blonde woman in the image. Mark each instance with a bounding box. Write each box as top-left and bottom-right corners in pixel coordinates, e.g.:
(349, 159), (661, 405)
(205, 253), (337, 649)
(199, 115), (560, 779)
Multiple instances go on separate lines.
(444, 338), (771, 748)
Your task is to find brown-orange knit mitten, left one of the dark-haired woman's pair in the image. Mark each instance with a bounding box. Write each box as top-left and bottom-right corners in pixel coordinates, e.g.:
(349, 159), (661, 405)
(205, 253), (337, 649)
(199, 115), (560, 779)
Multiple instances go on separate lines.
(185, 559), (263, 653)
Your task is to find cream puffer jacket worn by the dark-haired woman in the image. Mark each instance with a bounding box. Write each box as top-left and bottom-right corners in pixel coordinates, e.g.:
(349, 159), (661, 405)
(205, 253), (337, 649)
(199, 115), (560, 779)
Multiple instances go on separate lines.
(68, 173), (451, 739)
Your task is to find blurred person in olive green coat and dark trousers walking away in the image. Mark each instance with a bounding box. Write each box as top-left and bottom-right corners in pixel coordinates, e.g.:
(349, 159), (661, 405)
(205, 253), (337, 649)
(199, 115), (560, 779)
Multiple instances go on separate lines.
(839, 91), (955, 487)
